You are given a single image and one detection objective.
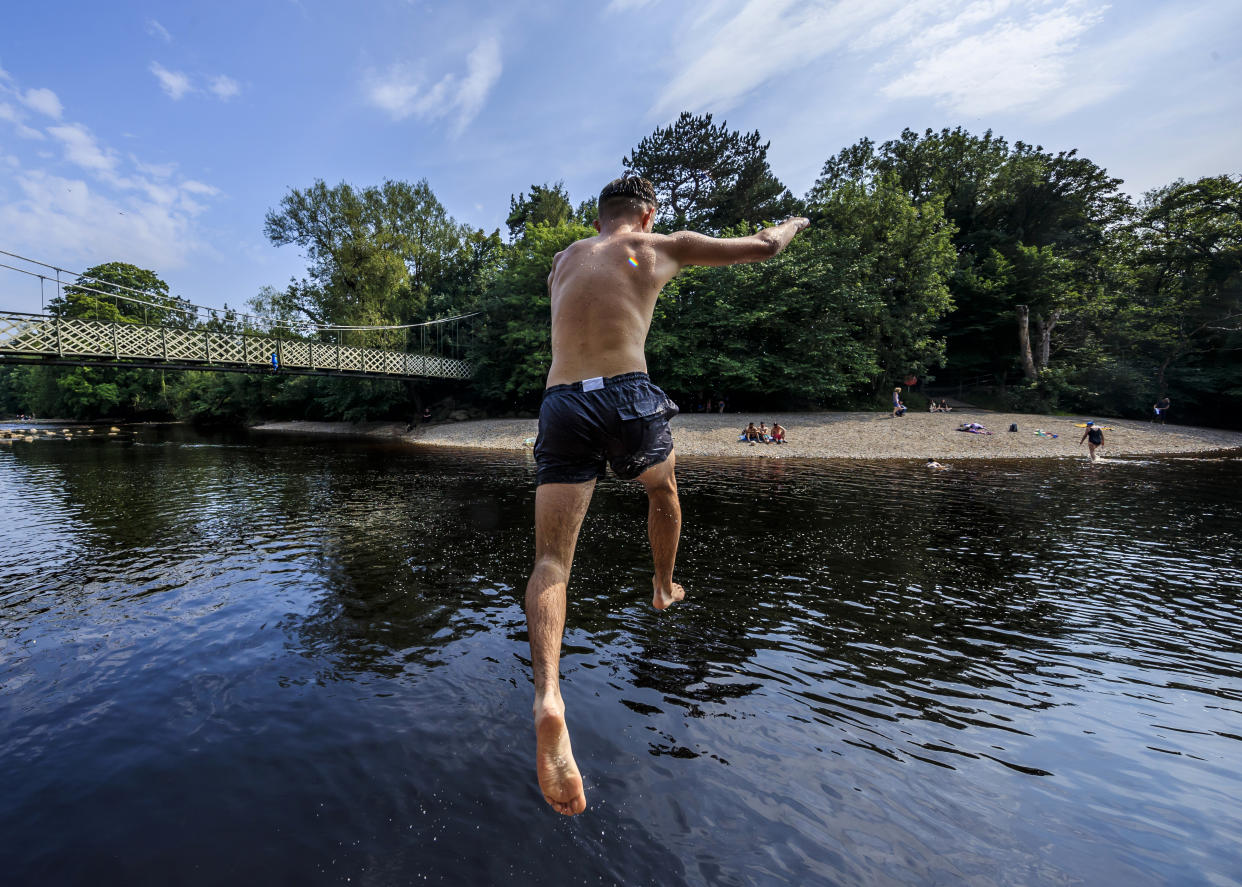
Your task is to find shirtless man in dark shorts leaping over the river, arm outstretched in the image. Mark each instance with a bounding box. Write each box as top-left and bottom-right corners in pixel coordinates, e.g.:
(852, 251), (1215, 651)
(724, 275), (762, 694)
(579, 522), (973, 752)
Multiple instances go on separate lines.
(527, 175), (809, 816)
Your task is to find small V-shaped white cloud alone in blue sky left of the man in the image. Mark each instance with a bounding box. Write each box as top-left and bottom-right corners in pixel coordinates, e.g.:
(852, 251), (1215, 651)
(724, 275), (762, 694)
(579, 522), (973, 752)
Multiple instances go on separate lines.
(366, 37), (503, 133)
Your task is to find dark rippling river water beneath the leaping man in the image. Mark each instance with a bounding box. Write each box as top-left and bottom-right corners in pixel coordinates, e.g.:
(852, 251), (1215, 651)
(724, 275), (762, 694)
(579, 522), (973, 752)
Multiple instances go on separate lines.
(0, 429), (1242, 886)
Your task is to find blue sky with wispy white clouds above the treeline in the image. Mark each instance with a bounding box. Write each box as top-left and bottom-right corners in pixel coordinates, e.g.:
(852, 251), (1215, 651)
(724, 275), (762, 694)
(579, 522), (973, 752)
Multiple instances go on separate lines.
(0, 0), (1242, 311)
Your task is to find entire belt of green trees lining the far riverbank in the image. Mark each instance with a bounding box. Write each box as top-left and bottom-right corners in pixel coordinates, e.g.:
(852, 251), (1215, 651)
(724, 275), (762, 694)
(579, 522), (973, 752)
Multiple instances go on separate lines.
(0, 132), (1242, 425)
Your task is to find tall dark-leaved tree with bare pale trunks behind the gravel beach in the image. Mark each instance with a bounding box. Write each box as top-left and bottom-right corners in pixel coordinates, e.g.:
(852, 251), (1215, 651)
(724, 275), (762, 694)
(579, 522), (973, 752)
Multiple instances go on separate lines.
(811, 127), (1130, 379)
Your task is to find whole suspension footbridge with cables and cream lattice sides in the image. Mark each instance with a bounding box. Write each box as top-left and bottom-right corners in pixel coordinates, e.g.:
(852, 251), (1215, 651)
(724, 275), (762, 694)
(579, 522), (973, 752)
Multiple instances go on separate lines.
(0, 250), (479, 379)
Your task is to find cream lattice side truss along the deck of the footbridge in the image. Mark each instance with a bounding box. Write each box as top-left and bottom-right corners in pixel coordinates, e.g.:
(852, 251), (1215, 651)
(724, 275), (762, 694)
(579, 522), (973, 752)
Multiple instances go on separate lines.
(0, 312), (472, 379)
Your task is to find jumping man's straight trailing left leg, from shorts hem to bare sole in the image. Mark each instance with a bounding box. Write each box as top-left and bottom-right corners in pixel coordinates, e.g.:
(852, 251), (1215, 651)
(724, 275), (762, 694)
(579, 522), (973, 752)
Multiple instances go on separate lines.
(527, 481), (595, 816)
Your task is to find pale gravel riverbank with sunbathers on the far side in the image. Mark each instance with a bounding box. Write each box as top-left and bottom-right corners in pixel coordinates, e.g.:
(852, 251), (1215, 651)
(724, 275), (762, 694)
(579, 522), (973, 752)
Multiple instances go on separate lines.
(255, 407), (1242, 461)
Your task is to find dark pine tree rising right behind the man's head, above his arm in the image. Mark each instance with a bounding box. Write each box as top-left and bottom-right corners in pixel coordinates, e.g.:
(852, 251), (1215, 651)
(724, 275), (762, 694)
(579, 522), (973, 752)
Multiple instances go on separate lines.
(621, 112), (799, 234)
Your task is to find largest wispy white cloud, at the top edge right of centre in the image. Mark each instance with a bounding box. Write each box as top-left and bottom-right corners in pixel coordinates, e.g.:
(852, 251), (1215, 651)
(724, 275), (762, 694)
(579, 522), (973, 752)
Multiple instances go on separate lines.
(650, 0), (1123, 118)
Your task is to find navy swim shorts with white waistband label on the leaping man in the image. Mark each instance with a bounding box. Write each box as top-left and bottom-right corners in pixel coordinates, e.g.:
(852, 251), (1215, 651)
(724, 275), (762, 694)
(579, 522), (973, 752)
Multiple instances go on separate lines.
(535, 373), (678, 487)
